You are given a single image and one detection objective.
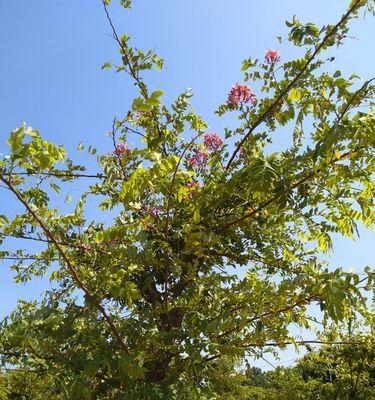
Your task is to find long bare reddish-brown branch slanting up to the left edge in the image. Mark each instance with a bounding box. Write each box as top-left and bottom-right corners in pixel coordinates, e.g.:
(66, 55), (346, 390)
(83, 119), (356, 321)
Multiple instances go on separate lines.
(0, 174), (129, 354)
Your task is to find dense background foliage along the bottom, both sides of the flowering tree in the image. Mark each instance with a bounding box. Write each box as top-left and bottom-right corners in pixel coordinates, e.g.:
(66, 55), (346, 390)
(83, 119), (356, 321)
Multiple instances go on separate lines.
(0, 335), (375, 400)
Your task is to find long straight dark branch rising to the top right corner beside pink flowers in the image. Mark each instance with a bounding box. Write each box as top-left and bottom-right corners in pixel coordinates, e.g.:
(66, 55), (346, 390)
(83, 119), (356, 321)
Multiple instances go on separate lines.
(225, 0), (368, 171)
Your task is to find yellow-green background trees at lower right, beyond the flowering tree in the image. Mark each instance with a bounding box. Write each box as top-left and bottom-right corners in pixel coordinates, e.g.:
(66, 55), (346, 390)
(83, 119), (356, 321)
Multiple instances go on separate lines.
(244, 334), (375, 400)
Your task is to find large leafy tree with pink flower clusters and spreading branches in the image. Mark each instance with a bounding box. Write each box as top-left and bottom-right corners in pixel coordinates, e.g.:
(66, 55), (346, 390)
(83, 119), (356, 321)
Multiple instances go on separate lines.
(0, 0), (375, 399)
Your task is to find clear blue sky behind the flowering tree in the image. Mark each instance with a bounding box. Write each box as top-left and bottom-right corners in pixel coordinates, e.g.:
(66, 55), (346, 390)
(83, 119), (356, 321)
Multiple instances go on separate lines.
(0, 0), (375, 368)
